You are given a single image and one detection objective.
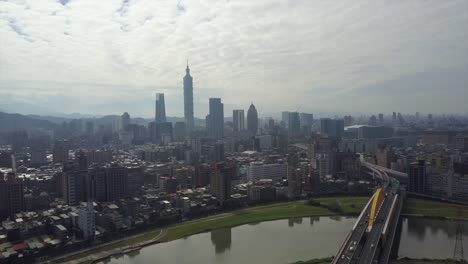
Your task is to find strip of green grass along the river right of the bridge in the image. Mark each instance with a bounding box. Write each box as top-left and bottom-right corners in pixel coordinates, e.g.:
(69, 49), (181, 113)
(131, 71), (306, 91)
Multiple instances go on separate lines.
(402, 198), (468, 220)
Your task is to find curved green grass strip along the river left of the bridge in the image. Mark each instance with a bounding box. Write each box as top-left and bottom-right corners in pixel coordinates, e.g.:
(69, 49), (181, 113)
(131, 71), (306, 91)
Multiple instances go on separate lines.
(165, 197), (369, 241)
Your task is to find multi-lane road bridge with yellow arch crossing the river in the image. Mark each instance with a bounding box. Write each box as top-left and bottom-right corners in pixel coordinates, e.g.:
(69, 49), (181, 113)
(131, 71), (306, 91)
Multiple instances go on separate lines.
(332, 162), (407, 264)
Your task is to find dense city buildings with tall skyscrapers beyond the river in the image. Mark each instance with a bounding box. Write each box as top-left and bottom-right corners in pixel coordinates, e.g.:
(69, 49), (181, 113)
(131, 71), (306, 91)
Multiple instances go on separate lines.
(0, 62), (468, 263)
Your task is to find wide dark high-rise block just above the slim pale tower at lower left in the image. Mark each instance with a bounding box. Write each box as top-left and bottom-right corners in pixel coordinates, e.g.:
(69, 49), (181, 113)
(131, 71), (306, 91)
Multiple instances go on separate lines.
(88, 163), (128, 202)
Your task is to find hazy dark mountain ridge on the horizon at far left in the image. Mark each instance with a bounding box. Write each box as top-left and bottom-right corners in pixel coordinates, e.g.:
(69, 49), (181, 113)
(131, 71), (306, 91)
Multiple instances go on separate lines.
(0, 112), (58, 132)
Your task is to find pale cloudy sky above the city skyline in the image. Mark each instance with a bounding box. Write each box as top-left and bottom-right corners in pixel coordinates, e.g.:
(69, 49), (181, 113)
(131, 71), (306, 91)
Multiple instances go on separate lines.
(0, 0), (468, 117)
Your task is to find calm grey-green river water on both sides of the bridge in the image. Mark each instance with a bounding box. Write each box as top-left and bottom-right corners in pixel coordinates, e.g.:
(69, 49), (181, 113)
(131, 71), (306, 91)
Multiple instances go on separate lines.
(101, 216), (468, 264)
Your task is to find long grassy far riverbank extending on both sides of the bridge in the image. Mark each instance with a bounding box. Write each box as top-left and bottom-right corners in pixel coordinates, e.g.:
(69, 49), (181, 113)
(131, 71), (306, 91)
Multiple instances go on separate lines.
(56, 197), (468, 263)
